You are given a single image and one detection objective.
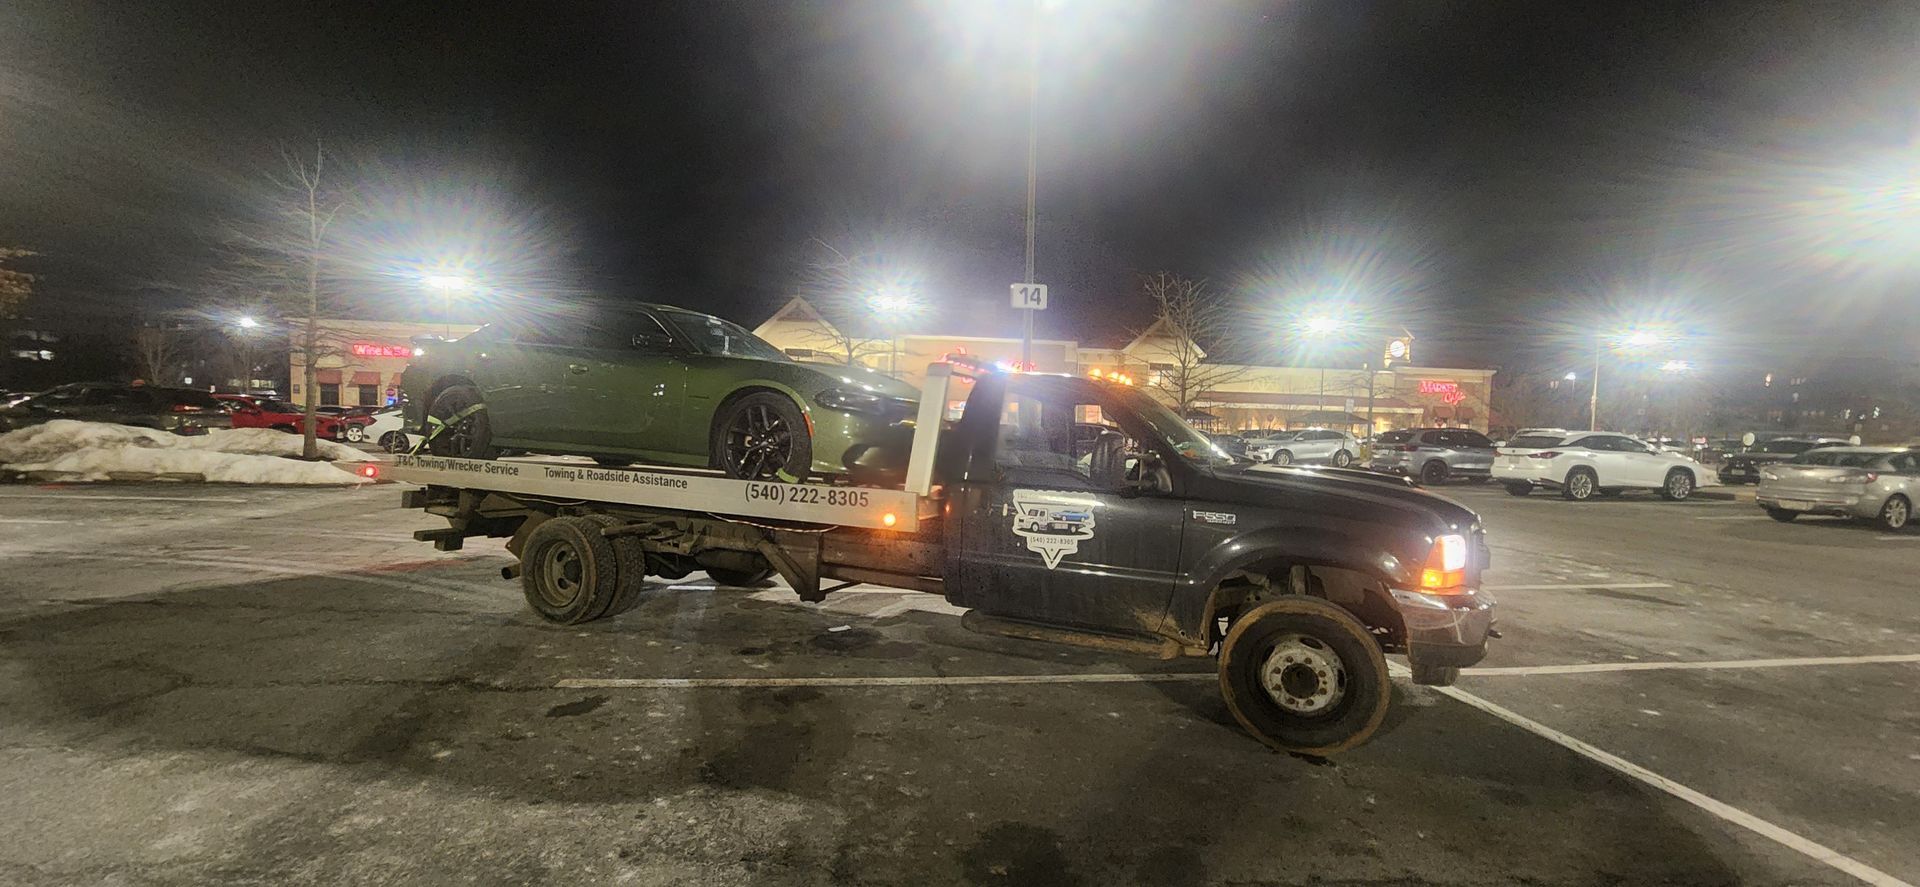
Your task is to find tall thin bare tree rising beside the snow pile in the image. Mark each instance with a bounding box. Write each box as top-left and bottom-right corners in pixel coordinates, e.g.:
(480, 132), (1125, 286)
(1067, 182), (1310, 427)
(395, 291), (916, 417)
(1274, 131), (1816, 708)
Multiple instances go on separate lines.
(221, 144), (353, 459)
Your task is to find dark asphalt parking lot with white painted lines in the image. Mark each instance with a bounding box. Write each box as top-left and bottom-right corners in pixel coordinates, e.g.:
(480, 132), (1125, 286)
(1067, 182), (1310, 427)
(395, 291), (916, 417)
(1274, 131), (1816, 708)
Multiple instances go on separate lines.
(0, 486), (1920, 885)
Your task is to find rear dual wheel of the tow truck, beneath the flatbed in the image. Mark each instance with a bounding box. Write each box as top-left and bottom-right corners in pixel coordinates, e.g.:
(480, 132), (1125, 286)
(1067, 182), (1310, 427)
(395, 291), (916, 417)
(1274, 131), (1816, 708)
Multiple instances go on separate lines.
(520, 516), (620, 626)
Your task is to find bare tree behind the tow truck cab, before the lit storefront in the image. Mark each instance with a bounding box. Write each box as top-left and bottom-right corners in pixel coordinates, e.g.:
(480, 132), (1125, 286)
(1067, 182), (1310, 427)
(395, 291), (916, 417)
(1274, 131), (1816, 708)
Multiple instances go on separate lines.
(1139, 271), (1250, 417)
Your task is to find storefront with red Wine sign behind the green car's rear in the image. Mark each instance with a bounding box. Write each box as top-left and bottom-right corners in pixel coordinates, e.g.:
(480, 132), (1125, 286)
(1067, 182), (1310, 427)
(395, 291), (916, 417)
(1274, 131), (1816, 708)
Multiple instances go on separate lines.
(288, 319), (480, 407)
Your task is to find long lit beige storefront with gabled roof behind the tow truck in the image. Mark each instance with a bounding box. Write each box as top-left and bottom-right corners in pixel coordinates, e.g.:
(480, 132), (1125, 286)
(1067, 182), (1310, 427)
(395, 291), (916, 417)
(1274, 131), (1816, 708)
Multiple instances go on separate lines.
(753, 298), (1494, 436)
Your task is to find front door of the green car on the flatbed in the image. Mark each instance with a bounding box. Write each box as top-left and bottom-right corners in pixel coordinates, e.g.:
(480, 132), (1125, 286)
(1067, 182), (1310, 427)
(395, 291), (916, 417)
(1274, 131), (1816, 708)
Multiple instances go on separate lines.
(541, 309), (707, 465)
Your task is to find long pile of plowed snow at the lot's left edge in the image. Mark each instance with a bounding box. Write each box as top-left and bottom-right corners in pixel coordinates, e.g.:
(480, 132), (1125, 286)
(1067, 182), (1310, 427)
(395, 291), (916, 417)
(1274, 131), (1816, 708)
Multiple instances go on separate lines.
(0, 419), (372, 486)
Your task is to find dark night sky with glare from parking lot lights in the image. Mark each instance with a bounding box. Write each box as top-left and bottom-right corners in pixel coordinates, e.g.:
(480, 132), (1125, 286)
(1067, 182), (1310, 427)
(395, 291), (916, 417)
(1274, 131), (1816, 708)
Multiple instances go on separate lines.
(0, 0), (1920, 367)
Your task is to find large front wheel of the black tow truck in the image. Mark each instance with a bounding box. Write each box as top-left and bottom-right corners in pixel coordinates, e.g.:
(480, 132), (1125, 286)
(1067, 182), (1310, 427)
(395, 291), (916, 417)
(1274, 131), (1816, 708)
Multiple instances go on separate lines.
(1219, 597), (1392, 756)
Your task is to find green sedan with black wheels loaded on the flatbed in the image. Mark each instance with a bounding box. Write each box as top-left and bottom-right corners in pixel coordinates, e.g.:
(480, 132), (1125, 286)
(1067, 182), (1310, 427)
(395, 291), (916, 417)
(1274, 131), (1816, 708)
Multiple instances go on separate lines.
(401, 303), (920, 482)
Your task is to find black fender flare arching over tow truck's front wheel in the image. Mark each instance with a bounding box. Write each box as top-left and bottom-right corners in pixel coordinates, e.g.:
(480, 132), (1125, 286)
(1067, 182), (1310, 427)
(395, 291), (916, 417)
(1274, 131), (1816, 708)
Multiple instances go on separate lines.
(1167, 526), (1409, 643)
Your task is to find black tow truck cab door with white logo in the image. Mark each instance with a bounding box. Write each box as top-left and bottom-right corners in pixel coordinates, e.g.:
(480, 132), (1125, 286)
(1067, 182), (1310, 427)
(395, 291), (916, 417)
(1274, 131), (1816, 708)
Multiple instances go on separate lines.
(947, 376), (1185, 632)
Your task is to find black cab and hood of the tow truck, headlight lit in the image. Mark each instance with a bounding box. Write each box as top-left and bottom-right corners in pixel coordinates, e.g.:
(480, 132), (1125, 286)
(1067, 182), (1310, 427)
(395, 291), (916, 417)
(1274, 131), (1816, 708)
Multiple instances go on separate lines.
(939, 366), (1492, 683)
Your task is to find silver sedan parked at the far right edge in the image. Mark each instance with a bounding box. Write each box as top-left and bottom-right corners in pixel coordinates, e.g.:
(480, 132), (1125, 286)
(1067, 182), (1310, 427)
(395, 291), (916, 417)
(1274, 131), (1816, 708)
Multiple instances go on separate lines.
(1753, 447), (1920, 530)
